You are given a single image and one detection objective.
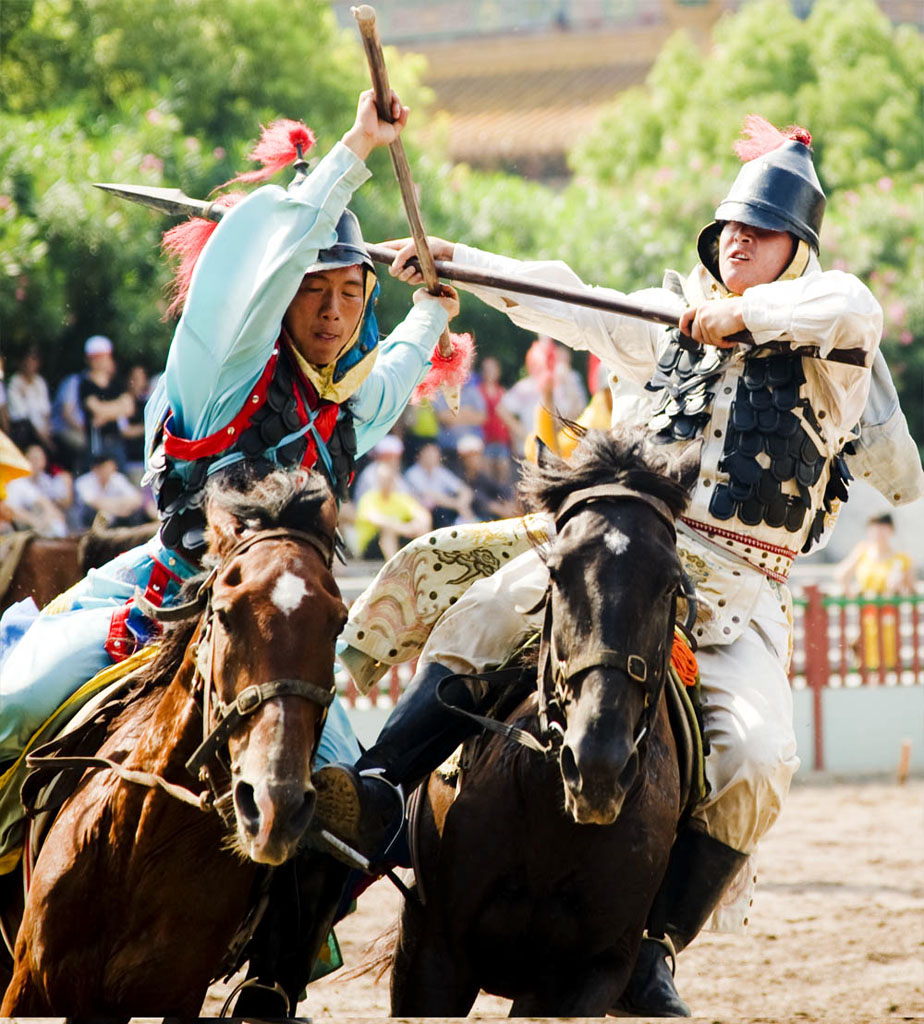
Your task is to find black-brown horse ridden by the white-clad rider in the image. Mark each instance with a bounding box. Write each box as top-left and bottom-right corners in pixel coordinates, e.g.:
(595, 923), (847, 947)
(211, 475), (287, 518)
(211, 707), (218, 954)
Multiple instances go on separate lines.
(391, 433), (699, 1017)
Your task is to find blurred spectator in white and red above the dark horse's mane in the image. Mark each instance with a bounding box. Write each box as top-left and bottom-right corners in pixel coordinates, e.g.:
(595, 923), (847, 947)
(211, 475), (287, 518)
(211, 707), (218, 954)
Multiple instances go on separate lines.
(498, 335), (587, 455)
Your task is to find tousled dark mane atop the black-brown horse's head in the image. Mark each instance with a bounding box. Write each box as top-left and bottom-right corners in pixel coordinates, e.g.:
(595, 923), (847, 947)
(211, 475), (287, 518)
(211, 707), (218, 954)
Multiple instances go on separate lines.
(518, 424), (689, 516)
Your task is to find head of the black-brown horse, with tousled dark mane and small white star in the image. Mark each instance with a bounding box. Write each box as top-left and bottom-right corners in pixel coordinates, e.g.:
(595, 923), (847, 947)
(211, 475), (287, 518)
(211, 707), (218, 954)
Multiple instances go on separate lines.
(521, 431), (700, 824)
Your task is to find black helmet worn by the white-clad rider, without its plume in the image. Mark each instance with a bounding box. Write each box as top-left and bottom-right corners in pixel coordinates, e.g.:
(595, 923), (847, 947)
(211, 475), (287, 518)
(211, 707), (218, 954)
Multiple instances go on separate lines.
(697, 133), (826, 279)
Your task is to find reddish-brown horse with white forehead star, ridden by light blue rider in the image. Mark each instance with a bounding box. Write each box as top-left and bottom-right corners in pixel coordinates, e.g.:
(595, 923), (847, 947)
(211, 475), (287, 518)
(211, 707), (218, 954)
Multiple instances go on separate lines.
(0, 471), (346, 1017)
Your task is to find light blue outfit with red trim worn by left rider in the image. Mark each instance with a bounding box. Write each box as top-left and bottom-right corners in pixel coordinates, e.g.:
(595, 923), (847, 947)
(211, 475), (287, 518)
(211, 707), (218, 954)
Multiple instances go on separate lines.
(0, 94), (458, 764)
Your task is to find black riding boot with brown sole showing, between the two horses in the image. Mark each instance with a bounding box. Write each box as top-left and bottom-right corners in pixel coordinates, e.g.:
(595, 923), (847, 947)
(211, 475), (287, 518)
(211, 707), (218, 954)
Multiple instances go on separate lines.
(314, 662), (478, 857)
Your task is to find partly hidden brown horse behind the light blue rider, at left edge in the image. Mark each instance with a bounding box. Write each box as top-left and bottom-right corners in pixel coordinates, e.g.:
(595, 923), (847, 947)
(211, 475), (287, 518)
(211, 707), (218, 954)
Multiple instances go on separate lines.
(0, 522), (158, 612)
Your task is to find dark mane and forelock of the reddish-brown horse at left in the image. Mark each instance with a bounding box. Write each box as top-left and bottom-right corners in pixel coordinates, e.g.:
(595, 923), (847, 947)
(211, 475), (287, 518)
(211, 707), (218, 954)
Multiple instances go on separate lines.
(138, 466), (331, 689)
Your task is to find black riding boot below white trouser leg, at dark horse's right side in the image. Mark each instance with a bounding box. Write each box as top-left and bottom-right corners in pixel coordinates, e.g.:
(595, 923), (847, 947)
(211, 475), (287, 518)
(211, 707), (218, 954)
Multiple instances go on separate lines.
(619, 824), (748, 1017)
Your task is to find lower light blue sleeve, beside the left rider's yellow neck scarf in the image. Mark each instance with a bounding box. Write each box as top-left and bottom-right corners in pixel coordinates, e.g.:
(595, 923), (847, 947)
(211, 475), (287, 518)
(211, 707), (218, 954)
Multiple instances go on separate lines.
(347, 299), (448, 455)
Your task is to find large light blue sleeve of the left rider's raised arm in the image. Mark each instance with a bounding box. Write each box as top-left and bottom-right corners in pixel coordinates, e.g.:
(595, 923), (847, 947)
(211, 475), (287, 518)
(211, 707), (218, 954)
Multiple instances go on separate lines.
(165, 142), (369, 440)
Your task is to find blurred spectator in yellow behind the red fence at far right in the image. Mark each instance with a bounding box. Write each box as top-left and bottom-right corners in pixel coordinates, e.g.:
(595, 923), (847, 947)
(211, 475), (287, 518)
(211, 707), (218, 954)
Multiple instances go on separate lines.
(836, 513), (915, 671)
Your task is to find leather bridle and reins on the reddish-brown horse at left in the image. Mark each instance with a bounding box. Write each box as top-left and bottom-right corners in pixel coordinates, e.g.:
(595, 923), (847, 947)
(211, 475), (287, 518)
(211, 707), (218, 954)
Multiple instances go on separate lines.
(28, 526), (336, 825)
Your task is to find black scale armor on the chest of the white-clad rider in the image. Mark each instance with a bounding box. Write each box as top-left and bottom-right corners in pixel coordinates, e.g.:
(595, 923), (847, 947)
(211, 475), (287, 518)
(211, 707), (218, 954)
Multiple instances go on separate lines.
(646, 332), (852, 552)
